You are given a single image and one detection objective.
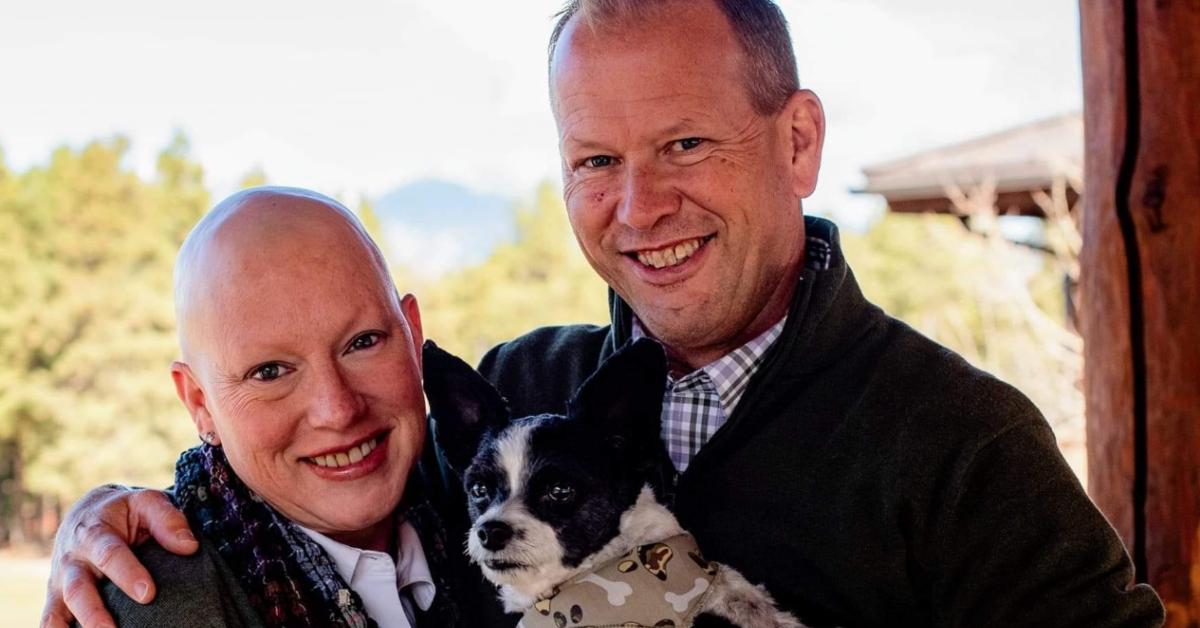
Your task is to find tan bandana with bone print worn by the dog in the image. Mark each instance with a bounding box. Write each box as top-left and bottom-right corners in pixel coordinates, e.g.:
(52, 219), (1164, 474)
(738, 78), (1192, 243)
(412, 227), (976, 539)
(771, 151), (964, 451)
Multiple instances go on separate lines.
(517, 534), (721, 628)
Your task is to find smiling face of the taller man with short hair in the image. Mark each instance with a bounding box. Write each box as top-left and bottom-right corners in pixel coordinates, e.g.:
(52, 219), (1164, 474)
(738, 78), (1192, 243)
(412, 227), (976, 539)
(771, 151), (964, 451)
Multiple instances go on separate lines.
(551, 2), (820, 366)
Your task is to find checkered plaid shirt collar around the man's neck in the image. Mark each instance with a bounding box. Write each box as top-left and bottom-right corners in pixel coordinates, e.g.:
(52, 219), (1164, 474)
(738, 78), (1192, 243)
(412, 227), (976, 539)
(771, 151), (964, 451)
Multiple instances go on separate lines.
(630, 235), (833, 417)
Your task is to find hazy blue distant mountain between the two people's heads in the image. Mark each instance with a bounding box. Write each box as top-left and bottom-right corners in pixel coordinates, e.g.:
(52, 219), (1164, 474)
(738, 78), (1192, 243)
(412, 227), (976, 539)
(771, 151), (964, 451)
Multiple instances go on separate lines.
(372, 179), (515, 279)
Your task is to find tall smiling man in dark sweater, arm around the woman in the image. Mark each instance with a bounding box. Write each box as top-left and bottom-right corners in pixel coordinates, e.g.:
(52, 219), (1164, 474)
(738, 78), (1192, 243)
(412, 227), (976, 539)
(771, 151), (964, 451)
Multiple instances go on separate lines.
(39, 0), (1164, 628)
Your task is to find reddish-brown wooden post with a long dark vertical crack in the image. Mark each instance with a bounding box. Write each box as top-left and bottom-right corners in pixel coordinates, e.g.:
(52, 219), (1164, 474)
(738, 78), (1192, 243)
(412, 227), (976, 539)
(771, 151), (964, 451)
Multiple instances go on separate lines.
(1080, 0), (1200, 628)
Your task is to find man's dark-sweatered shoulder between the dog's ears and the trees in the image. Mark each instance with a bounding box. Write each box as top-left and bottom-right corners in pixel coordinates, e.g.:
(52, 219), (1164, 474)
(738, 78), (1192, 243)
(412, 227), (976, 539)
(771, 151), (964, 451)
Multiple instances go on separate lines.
(479, 325), (612, 417)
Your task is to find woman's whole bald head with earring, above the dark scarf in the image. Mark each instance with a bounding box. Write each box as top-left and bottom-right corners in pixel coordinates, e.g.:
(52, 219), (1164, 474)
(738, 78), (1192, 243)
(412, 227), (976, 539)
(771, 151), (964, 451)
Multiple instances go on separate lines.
(172, 187), (425, 540)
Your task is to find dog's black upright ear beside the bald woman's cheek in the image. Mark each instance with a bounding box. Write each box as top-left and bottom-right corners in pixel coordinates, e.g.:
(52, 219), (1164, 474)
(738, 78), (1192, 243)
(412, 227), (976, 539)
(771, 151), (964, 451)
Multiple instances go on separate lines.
(422, 341), (509, 476)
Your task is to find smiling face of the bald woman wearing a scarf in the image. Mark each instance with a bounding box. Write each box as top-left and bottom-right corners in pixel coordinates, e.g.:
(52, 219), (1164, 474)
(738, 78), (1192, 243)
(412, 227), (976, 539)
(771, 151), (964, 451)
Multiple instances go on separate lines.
(175, 215), (425, 536)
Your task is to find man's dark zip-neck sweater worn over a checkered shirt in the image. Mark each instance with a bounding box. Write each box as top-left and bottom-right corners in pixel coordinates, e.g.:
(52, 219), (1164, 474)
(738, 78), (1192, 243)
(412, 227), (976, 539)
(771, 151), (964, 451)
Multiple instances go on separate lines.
(434, 217), (1164, 628)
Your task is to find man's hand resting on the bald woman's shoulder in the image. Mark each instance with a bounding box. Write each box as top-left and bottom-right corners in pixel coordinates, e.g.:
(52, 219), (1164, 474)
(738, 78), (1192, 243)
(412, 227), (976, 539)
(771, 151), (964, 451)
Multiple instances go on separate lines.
(41, 485), (199, 628)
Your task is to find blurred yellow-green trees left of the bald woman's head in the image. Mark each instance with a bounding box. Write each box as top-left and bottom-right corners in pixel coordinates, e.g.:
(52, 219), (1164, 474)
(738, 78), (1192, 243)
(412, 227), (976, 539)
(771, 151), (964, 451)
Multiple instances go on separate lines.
(0, 136), (210, 513)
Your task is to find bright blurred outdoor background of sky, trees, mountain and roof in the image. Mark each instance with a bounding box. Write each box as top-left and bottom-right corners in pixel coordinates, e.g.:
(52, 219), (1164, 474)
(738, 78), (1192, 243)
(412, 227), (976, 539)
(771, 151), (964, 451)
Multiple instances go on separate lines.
(0, 0), (1085, 626)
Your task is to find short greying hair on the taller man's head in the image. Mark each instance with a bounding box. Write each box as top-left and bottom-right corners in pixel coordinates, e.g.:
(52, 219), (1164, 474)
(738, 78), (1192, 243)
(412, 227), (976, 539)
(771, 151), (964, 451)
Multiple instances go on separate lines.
(550, 0), (800, 115)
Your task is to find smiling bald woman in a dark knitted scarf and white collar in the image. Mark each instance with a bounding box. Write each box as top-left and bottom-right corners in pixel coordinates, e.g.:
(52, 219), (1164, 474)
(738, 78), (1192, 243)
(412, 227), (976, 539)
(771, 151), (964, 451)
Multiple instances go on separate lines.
(65, 187), (484, 628)
